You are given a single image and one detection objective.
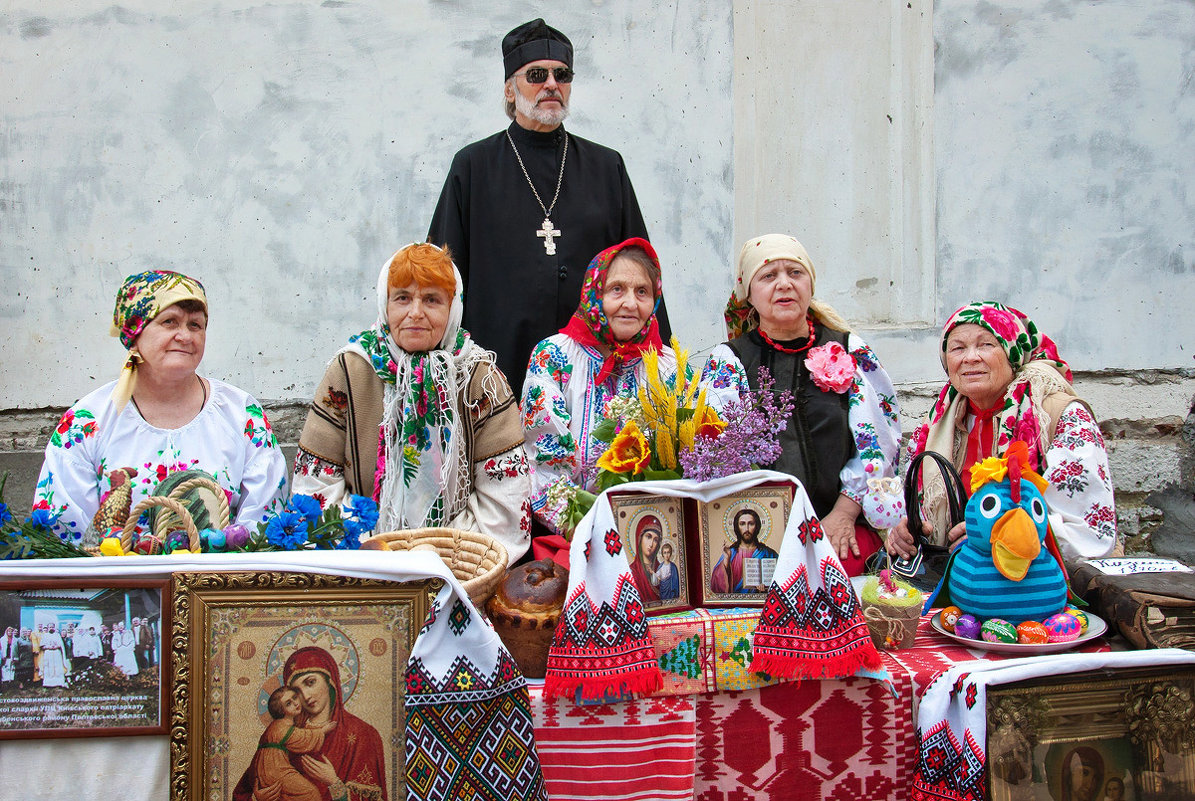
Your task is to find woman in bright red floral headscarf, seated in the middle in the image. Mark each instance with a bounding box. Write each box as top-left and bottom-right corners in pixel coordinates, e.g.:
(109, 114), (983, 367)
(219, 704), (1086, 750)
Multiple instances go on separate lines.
(521, 238), (676, 542)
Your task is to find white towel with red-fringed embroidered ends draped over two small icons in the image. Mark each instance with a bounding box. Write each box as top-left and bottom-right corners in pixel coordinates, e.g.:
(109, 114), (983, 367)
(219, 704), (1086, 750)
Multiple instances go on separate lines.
(544, 470), (881, 698)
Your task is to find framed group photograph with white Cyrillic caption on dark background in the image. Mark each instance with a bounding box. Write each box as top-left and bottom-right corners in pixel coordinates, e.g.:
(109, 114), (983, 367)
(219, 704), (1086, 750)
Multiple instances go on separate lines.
(0, 579), (171, 739)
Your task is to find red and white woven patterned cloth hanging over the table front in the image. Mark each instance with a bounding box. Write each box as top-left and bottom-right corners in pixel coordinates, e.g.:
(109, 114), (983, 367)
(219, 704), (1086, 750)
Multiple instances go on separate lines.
(531, 614), (1128, 801)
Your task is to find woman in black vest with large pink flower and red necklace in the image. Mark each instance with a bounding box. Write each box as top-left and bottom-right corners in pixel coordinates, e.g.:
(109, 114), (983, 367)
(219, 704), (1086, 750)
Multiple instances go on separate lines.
(703, 234), (900, 575)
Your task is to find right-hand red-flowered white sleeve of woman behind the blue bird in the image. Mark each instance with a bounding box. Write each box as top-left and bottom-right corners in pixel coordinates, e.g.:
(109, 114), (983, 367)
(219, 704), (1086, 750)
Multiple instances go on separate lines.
(1043, 403), (1116, 558)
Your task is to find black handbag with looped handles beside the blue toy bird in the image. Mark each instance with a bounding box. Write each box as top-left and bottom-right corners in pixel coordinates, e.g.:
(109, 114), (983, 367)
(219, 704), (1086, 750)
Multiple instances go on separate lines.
(868, 451), (967, 592)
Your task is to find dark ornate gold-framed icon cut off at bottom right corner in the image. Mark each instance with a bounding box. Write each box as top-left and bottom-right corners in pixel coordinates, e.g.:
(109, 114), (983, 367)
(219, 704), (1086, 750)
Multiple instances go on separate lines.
(987, 666), (1195, 801)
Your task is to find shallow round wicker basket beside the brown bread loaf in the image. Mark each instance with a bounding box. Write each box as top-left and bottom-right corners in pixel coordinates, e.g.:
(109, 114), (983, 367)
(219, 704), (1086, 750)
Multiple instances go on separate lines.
(369, 528), (507, 609)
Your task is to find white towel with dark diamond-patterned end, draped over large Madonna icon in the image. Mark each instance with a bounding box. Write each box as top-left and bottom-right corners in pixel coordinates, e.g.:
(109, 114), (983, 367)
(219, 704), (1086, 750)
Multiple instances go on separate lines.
(4, 551), (547, 801)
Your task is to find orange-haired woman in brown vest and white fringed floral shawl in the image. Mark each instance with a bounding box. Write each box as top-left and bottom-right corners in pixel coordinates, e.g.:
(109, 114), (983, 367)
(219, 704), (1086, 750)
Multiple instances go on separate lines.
(293, 244), (531, 563)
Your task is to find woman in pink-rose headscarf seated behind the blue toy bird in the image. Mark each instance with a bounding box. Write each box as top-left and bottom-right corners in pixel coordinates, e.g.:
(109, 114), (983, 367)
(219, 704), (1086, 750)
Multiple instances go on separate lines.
(888, 301), (1116, 558)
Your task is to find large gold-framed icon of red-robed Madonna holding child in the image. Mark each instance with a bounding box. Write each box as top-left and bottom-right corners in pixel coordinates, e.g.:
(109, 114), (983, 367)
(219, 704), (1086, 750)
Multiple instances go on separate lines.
(171, 573), (439, 801)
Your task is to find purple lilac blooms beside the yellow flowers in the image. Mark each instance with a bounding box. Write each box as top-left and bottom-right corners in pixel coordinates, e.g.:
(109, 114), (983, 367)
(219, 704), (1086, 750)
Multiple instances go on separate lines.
(679, 367), (793, 481)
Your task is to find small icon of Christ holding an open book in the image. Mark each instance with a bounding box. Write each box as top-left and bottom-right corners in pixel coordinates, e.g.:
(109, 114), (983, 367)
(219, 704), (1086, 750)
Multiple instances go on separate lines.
(693, 484), (792, 606)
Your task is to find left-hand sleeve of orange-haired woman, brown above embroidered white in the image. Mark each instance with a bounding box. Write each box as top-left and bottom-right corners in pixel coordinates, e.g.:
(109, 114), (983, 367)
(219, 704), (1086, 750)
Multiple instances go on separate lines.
(290, 361), (349, 505)
